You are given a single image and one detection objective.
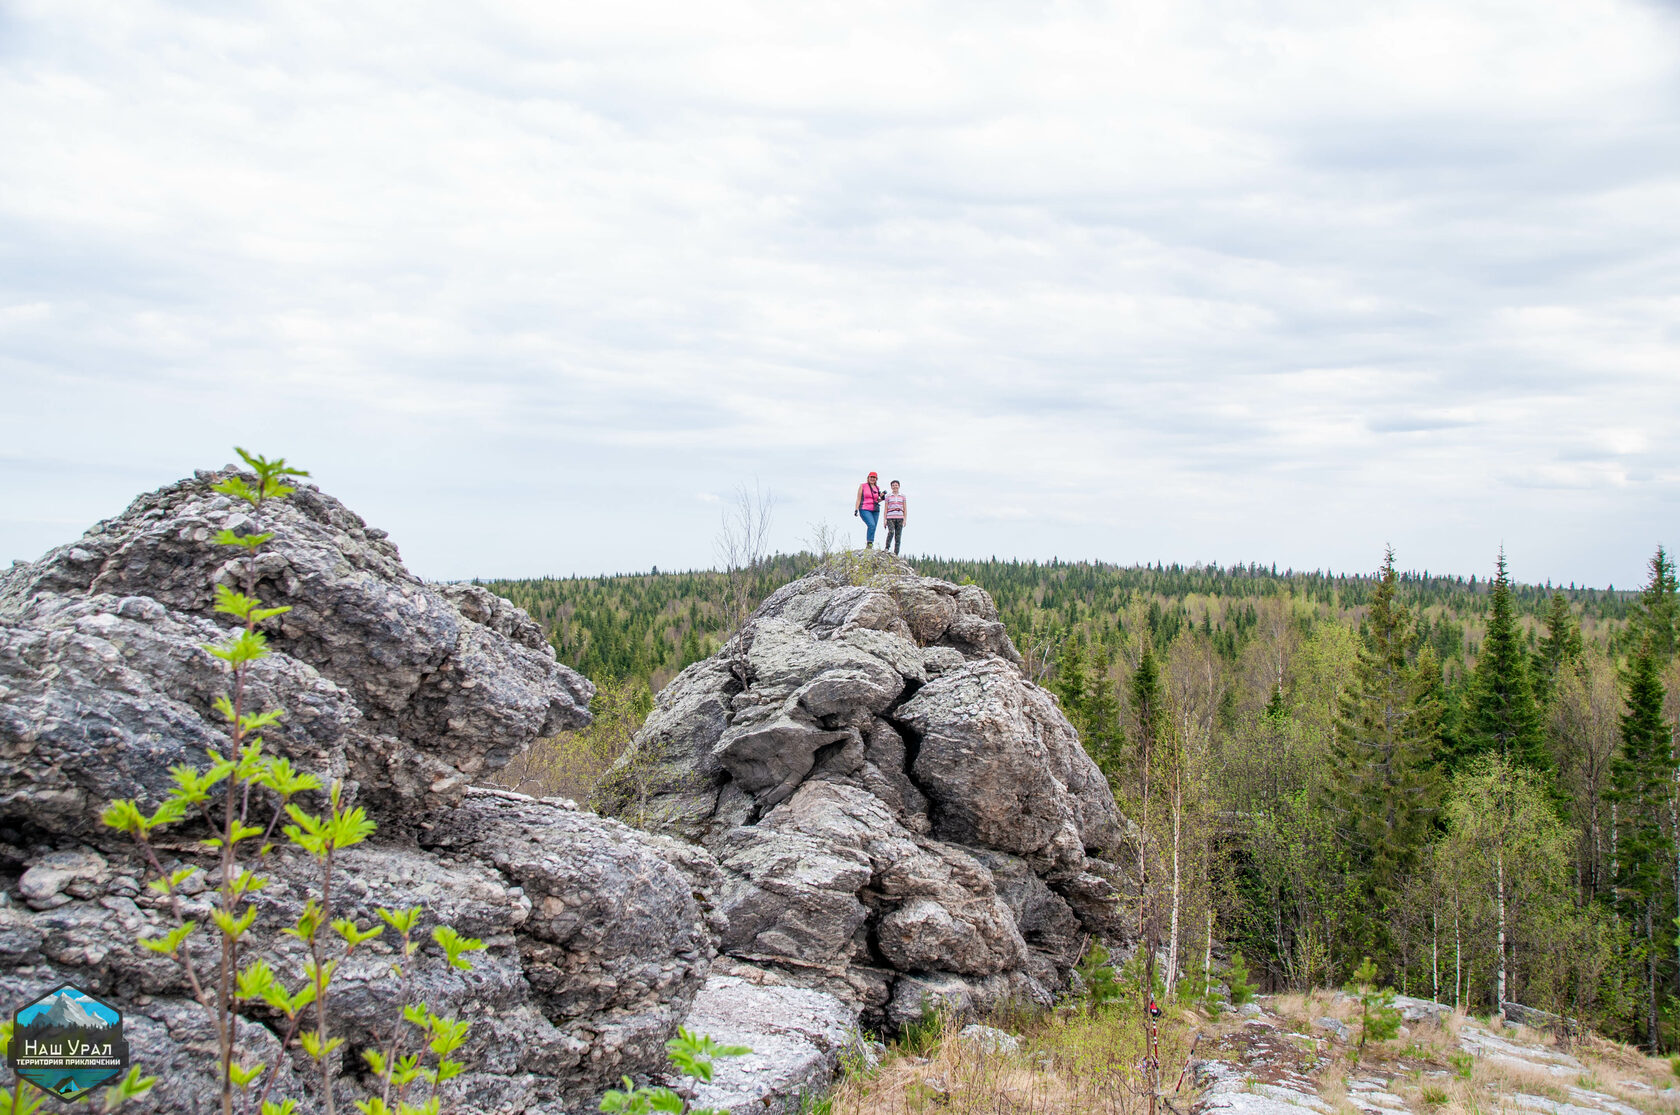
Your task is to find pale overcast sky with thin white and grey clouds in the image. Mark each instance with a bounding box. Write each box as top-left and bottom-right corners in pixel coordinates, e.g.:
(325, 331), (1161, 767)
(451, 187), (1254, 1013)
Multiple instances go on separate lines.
(0, 0), (1680, 588)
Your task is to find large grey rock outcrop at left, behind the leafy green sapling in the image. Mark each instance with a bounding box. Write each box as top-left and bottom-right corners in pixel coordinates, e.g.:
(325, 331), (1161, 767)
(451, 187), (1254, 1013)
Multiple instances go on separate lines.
(0, 475), (721, 1115)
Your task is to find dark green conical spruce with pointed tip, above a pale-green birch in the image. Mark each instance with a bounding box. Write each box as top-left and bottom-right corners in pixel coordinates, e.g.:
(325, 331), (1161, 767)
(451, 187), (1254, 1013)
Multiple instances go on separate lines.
(1458, 549), (1552, 786)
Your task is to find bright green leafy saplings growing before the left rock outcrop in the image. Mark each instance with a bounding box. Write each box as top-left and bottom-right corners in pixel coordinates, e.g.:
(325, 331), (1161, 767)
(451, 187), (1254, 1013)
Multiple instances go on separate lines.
(95, 450), (484, 1115)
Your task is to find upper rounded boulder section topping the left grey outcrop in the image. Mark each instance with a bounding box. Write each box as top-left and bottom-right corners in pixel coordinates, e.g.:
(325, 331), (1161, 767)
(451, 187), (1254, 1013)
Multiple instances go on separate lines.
(0, 474), (593, 831)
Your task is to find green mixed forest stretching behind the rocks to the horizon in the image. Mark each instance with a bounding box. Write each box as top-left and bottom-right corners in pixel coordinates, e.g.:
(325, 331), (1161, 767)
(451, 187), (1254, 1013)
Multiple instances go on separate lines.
(486, 549), (1680, 1050)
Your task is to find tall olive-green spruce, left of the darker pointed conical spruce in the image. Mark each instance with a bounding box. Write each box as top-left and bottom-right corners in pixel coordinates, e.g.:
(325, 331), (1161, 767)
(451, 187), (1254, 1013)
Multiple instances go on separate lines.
(1331, 549), (1440, 955)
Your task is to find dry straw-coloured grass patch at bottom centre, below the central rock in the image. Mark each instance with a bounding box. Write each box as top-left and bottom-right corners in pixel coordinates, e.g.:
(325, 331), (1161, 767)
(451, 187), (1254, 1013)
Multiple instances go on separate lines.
(820, 1009), (1188, 1115)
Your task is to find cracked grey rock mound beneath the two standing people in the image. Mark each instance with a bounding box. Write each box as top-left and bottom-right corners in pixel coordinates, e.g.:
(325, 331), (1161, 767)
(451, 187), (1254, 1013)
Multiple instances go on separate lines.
(600, 556), (1126, 1026)
